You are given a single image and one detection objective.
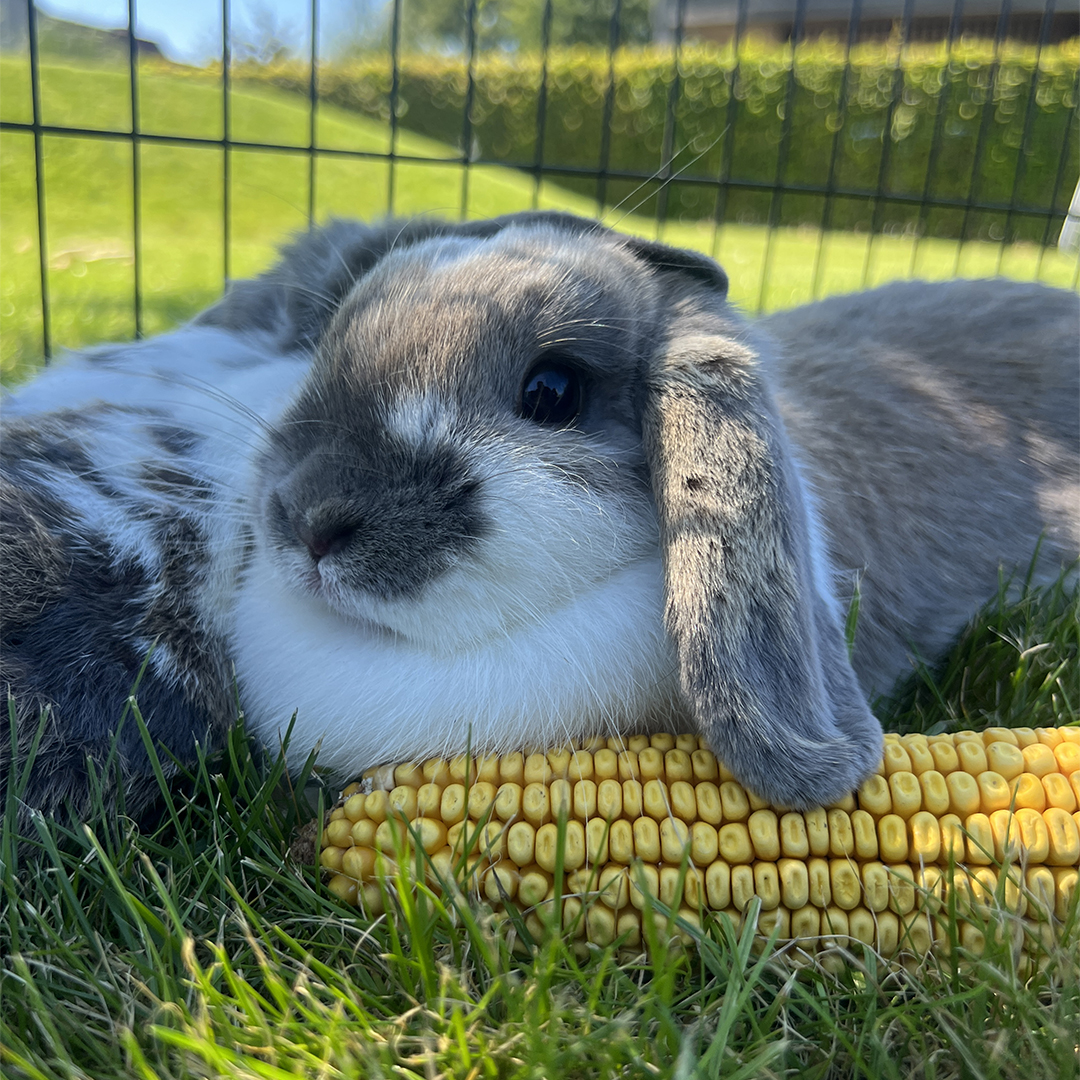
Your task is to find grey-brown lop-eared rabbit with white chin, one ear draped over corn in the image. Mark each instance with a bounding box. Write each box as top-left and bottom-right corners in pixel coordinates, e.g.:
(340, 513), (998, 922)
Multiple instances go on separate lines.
(200, 214), (1080, 807)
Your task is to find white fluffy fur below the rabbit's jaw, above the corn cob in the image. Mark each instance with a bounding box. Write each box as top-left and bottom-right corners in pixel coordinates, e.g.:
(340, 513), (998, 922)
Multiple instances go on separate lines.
(233, 555), (687, 779)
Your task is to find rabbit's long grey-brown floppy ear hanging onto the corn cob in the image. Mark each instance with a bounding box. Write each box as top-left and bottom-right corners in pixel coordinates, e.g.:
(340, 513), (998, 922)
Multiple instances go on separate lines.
(636, 244), (882, 807)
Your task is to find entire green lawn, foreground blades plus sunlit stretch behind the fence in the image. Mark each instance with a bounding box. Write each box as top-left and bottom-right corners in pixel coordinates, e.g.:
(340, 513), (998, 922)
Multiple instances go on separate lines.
(0, 59), (1080, 1080)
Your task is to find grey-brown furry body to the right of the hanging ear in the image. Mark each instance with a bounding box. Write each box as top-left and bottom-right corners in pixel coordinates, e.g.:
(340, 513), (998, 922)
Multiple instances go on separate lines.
(762, 281), (1080, 693)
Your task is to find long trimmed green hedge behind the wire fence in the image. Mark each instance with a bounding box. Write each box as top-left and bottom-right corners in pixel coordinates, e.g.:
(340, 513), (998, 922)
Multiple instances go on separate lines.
(245, 40), (1080, 240)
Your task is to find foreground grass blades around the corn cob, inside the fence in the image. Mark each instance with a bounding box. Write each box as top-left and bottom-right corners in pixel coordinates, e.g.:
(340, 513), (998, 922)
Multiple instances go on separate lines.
(0, 579), (1080, 1080)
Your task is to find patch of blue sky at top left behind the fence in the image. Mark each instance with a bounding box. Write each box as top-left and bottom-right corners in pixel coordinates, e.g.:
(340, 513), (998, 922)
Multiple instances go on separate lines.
(38, 0), (364, 64)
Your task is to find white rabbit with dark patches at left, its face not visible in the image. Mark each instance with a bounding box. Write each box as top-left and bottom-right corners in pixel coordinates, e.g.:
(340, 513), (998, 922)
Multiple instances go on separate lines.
(0, 327), (309, 824)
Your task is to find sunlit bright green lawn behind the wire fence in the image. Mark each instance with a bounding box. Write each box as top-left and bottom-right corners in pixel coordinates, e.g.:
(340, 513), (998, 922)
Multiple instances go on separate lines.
(0, 57), (1077, 383)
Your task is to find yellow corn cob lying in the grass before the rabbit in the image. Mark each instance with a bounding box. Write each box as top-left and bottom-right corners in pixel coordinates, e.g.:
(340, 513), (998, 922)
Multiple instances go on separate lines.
(321, 728), (1080, 962)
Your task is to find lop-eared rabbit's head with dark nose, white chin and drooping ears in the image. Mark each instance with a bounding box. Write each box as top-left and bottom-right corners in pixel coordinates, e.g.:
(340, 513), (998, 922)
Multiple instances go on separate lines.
(217, 214), (881, 807)
